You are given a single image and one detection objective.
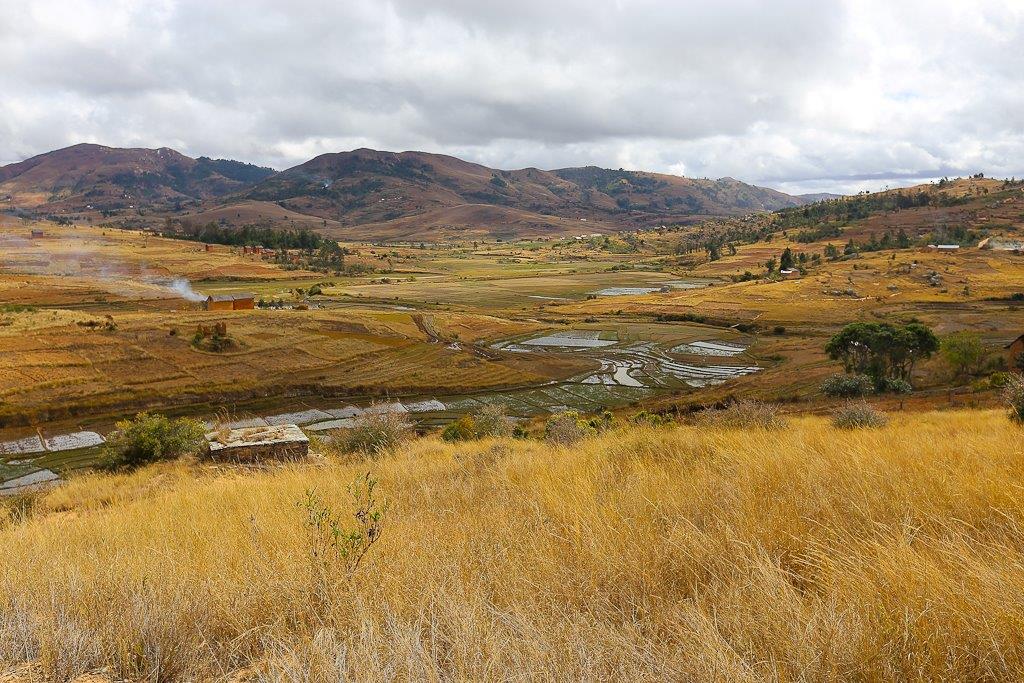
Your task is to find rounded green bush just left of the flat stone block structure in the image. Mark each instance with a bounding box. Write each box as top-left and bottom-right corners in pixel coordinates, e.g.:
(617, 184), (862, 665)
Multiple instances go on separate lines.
(100, 413), (206, 470)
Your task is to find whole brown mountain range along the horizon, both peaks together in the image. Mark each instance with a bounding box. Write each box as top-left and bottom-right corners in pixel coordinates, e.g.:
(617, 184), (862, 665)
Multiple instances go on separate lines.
(0, 144), (806, 241)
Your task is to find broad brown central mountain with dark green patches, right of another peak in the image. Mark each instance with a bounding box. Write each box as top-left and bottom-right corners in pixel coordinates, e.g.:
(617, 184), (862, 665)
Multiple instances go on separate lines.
(242, 148), (803, 239)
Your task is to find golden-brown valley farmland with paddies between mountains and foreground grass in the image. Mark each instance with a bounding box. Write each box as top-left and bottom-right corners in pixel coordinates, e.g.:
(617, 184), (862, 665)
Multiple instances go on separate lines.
(0, 181), (1024, 491)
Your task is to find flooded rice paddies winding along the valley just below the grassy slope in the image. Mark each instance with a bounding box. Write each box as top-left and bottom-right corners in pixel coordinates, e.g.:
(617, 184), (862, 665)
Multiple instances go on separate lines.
(0, 324), (760, 495)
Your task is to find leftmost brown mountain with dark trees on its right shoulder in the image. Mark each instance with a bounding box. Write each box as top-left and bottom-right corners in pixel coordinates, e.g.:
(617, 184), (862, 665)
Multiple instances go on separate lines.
(0, 144), (274, 212)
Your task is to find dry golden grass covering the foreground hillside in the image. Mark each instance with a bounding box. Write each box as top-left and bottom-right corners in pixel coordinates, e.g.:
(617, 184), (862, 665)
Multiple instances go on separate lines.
(0, 412), (1024, 681)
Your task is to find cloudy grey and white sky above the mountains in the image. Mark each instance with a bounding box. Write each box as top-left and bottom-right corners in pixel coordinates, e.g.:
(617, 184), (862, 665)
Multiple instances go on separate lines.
(0, 0), (1024, 194)
